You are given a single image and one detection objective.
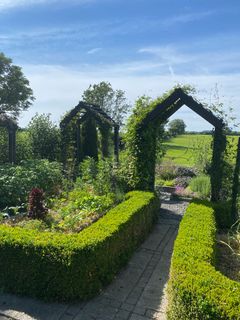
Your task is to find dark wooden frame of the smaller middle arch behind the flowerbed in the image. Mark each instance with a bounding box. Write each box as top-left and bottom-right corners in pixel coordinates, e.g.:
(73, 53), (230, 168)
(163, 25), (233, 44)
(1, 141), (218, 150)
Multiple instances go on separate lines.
(60, 101), (119, 168)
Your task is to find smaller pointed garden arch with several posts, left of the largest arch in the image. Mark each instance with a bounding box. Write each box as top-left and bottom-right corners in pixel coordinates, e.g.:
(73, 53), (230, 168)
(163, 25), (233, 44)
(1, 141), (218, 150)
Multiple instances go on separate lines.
(60, 101), (119, 168)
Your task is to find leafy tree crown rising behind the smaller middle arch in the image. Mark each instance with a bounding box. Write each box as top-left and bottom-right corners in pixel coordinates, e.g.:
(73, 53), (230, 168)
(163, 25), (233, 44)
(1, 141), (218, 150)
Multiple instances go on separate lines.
(82, 81), (130, 125)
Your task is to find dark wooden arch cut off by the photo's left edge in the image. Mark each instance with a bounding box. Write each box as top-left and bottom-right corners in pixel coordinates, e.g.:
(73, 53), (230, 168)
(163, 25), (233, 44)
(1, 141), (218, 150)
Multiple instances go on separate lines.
(0, 114), (18, 164)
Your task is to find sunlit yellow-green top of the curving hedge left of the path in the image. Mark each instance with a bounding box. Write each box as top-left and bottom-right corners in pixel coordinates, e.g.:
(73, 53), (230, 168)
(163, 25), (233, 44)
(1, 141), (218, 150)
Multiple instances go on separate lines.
(0, 191), (154, 253)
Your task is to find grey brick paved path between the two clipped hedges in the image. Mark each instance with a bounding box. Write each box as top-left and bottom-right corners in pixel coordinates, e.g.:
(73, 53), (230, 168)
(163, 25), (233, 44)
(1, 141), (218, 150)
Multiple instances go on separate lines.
(0, 201), (187, 320)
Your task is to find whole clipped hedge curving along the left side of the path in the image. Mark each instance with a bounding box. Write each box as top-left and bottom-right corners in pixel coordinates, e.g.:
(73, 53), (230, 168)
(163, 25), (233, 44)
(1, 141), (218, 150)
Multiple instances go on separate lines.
(0, 191), (159, 301)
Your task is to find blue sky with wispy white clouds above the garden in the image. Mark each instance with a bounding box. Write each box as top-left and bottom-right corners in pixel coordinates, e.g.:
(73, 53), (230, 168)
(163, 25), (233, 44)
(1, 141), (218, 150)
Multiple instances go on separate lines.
(0, 0), (240, 130)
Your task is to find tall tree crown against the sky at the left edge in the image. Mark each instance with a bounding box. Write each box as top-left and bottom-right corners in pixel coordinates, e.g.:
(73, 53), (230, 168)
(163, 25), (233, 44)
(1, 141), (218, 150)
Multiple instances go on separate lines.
(0, 53), (34, 117)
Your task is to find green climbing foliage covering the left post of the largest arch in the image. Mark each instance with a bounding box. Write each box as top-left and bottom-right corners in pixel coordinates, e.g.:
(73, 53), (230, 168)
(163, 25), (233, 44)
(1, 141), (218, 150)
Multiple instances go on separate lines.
(126, 86), (196, 190)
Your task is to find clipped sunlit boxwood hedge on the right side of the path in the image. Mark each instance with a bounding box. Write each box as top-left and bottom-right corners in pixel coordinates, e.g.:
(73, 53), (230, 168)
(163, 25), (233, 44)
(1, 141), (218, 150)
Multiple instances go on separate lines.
(168, 203), (240, 320)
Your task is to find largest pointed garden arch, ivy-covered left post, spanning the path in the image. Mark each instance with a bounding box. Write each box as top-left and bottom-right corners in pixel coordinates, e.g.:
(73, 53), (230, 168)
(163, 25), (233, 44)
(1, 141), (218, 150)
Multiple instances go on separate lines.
(134, 88), (226, 202)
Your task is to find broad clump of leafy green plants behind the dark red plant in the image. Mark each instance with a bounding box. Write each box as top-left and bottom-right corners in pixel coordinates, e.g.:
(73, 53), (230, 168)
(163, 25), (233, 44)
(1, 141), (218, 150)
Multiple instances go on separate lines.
(0, 160), (63, 208)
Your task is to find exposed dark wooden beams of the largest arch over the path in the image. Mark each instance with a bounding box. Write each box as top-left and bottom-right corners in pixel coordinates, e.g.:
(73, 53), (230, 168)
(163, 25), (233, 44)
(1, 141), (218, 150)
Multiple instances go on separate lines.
(138, 88), (226, 201)
